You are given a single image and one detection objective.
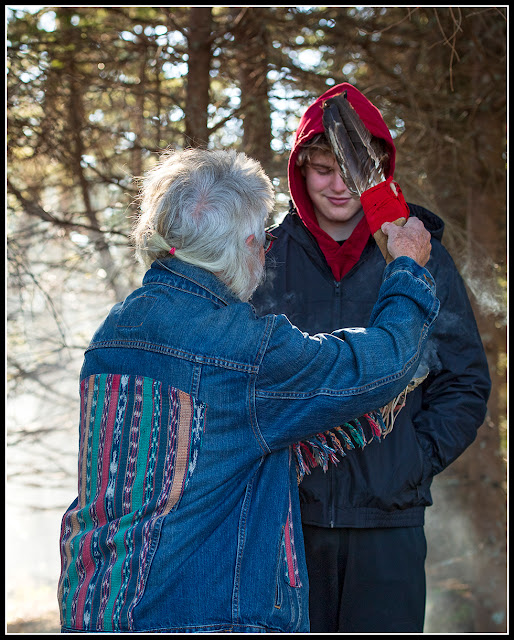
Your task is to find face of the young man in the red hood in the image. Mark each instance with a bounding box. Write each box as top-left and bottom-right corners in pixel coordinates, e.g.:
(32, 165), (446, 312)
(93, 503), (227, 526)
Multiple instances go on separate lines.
(303, 151), (363, 240)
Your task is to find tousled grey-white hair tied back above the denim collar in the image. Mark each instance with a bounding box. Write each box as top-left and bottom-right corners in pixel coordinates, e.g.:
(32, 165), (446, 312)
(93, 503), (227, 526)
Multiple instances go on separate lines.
(131, 149), (275, 300)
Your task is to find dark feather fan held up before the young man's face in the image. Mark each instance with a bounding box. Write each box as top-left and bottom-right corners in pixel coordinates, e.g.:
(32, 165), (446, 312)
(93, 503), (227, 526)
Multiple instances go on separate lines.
(323, 91), (385, 197)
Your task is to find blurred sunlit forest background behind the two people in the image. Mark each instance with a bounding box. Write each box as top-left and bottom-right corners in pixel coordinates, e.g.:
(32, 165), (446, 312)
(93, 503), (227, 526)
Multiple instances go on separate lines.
(6, 5), (508, 633)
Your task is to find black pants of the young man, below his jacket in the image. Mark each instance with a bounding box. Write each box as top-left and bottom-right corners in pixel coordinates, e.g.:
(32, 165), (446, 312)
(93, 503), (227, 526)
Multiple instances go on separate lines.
(303, 525), (426, 633)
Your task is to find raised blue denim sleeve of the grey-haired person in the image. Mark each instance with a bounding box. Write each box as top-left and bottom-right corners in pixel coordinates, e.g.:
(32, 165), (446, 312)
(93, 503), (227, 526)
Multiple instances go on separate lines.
(255, 258), (439, 451)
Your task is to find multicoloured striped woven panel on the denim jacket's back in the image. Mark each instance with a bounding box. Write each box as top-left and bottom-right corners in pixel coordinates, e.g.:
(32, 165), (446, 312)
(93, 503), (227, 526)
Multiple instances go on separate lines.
(58, 374), (205, 631)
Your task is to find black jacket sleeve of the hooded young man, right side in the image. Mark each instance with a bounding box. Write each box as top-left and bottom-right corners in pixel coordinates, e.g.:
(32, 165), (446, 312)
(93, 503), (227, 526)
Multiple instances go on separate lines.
(414, 245), (491, 476)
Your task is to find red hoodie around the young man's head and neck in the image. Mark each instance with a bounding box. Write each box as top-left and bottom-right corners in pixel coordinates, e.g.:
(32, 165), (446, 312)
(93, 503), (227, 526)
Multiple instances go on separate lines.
(287, 82), (396, 281)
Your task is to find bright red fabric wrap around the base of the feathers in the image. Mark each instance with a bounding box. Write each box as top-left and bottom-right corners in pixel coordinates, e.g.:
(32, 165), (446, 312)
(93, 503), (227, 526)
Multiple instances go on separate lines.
(361, 176), (409, 235)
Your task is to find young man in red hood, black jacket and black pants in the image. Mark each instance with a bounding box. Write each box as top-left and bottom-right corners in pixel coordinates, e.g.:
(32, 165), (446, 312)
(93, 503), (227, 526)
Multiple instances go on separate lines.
(252, 83), (490, 633)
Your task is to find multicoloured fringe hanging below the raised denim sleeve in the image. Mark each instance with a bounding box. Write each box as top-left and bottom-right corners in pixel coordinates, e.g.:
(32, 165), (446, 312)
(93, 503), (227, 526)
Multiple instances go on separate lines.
(293, 371), (428, 484)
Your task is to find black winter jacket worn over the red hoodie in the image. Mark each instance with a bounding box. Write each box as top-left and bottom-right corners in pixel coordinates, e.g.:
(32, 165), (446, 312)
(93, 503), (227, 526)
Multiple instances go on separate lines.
(252, 204), (490, 527)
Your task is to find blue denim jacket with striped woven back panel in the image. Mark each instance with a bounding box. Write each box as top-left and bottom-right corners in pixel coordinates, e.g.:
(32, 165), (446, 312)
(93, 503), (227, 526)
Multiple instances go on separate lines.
(58, 258), (439, 633)
